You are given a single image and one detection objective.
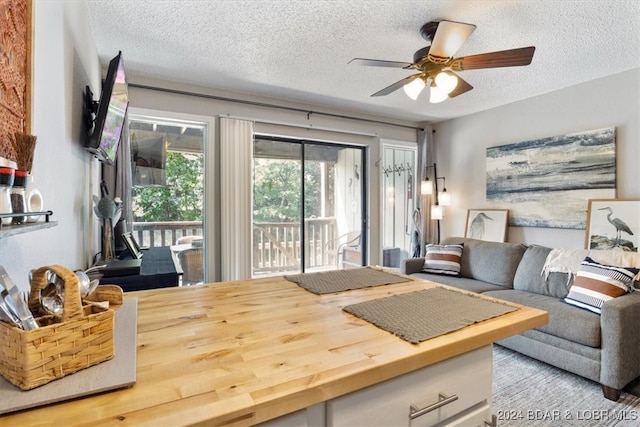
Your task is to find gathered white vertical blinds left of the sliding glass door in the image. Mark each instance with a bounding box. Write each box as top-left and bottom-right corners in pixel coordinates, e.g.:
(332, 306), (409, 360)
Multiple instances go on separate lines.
(220, 118), (253, 281)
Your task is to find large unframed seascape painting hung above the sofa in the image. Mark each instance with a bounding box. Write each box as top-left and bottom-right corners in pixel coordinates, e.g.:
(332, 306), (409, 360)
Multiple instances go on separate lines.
(486, 127), (616, 230)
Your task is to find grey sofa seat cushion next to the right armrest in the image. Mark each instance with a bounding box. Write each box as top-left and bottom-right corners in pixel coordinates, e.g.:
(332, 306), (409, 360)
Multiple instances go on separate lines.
(484, 289), (602, 348)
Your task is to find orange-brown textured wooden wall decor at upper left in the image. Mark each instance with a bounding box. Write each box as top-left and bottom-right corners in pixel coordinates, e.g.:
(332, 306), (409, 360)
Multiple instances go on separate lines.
(0, 0), (32, 160)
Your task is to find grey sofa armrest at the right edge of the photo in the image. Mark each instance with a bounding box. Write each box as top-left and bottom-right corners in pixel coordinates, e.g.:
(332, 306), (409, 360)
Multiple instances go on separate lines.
(600, 292), (640, 389)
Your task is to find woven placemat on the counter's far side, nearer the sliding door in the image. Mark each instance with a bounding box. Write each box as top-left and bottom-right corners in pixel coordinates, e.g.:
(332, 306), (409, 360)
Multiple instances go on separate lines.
(284, 267), (409, 295)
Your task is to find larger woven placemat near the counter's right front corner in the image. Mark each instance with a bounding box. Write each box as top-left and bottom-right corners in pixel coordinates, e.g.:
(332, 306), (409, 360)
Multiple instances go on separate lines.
(343, 288), (518, 344)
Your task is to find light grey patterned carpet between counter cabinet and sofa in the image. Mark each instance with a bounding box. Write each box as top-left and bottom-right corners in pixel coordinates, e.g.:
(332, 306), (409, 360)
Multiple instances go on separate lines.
(493, 345), (640, 427)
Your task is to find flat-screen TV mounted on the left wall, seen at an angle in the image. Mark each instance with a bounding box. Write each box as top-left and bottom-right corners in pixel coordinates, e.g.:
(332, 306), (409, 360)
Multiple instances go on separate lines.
(84, 52), (129, 165)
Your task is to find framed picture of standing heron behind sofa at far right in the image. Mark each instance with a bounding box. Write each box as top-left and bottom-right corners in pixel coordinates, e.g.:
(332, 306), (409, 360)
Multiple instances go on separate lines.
(585, 199), (640, 252)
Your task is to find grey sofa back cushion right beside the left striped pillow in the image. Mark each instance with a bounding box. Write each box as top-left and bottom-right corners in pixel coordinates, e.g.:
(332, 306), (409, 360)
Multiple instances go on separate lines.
(443, 237), (527, 288)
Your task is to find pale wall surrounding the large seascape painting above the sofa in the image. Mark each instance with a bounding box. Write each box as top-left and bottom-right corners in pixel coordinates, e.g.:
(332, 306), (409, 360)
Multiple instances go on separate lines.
(434, 69), (640, 248)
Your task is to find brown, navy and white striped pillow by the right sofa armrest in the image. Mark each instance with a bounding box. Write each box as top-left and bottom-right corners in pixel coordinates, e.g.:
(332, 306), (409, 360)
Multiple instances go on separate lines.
(564, 257), (640, 314)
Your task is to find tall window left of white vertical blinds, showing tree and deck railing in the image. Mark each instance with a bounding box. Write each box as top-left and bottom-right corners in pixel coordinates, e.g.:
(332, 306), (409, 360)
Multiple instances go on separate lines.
(129, 114), (206, 284)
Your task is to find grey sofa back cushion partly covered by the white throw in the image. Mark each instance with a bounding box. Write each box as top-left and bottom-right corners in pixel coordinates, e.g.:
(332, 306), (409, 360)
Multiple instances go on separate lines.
(513, 245), (573, 298)
